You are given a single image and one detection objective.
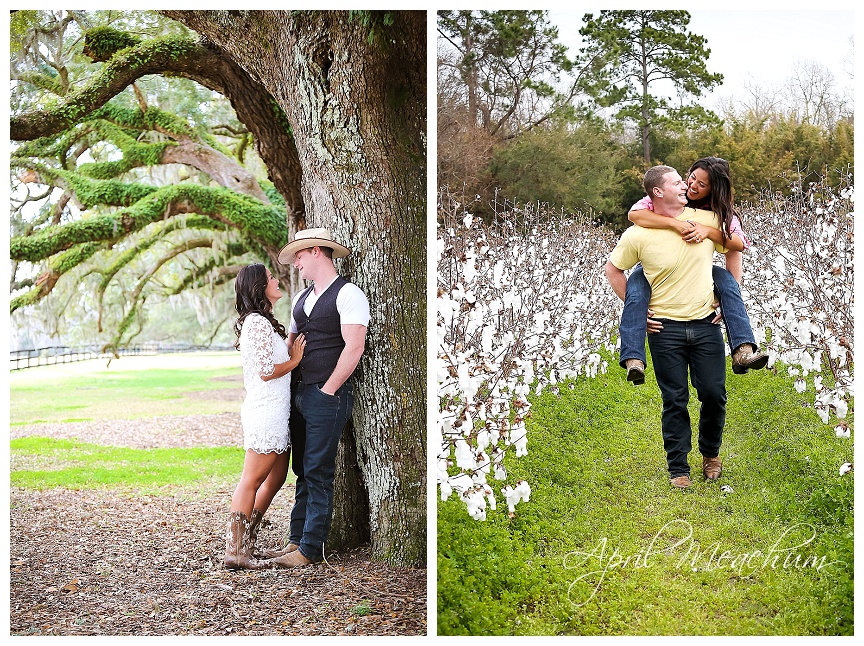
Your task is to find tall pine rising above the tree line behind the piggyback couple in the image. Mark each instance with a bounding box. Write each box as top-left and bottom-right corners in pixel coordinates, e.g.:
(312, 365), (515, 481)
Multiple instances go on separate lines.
(579, 10), (723, 165)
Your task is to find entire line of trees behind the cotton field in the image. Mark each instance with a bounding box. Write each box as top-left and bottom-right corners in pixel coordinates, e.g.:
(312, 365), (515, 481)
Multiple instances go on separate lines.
(437, 11), (854, 230)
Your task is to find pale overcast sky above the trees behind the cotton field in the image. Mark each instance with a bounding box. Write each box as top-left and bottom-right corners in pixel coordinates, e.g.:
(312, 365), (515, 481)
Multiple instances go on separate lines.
(549, 6), (854, 108)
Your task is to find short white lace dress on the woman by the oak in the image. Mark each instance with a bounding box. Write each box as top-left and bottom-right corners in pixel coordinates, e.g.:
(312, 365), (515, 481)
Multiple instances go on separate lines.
(240, 314), (291, 453)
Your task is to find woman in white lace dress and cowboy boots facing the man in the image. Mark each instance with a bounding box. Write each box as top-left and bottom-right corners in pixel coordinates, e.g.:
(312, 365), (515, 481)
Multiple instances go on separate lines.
(225, 264), (306, 569)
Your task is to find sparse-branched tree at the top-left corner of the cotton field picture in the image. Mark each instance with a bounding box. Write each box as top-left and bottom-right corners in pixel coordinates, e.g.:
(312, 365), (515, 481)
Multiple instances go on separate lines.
(438, 10), (598, 205)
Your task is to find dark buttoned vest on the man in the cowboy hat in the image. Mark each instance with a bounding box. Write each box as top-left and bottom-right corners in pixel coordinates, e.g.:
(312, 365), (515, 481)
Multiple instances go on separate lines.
(293, 276), (348, 384)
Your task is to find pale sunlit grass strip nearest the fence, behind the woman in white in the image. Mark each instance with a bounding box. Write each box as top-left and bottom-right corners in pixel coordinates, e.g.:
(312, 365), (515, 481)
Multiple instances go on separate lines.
(9, 352), (243, 426)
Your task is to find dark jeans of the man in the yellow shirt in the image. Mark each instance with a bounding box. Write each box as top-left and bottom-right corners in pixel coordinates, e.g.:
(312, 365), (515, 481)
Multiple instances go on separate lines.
(648, 316), (726, 478)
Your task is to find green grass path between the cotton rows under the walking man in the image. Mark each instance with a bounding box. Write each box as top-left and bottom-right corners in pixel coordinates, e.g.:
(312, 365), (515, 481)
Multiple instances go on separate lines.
(438, 364), (853, 635)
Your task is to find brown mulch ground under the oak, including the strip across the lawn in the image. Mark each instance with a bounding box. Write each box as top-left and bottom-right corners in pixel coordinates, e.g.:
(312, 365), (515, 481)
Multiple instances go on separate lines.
(9, 398), (427, 635)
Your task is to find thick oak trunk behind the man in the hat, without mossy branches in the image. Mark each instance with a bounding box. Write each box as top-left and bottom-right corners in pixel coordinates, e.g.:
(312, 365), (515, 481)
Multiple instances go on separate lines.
(164, 11), (426, 565)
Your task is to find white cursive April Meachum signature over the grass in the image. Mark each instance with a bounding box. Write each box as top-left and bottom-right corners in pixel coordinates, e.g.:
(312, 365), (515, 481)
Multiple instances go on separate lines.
(564, 519), (846, 607)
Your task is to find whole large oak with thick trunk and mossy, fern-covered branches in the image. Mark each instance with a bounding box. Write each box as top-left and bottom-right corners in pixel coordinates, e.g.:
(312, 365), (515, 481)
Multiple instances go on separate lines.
(11, 11), (426, 565)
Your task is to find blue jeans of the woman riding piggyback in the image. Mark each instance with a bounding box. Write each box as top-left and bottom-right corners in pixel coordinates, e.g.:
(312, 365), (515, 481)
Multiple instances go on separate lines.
(618, 265), (756, 368)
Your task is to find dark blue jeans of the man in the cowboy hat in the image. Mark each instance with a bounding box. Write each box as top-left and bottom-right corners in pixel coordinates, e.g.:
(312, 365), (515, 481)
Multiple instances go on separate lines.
(288, 381), (354, 562)
